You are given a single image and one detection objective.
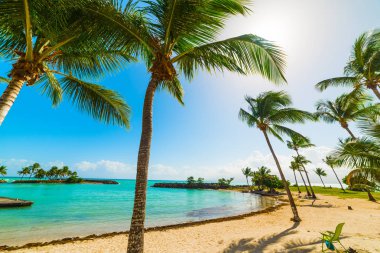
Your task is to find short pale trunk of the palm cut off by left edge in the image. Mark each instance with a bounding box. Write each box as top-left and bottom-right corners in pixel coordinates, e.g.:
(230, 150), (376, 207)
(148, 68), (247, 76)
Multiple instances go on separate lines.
(0, 76), (24, 126)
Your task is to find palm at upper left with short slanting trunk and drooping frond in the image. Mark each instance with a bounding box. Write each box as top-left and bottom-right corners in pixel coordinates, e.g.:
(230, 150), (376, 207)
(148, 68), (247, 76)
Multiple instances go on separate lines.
(0, 0), (131, 126)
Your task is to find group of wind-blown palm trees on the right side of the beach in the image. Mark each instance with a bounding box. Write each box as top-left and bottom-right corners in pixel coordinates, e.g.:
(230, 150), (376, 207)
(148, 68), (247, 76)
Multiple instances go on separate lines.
(239, 31), (380, 221)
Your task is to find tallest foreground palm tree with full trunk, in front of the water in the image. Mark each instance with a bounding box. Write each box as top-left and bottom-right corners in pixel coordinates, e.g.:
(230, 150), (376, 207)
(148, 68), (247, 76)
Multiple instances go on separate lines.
(86, 0), (285, 253)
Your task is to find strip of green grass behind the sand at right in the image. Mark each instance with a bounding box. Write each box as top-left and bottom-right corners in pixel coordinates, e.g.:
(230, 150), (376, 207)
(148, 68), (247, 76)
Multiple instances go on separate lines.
(290, 186), (380, 200)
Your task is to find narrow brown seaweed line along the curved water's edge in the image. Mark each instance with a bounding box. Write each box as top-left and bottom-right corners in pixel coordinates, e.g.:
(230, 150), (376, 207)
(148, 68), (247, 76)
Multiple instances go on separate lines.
(0, 198), (286, 251)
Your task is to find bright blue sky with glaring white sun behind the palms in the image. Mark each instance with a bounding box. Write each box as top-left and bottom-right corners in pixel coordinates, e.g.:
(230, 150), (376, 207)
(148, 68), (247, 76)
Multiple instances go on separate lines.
(0, 0), (380, 183)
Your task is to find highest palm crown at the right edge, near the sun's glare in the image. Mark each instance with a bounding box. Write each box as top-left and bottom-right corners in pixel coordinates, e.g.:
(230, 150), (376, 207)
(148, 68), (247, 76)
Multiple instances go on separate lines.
(316, 30), (380, 99)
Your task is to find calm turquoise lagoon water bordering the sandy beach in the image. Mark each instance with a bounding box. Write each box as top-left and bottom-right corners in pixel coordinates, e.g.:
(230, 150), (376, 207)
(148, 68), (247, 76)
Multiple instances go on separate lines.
(0, 180), (273, 245)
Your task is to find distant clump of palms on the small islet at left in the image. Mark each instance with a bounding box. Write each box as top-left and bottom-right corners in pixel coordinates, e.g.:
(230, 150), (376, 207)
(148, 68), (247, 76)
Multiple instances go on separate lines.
(17, 163), (78, 181)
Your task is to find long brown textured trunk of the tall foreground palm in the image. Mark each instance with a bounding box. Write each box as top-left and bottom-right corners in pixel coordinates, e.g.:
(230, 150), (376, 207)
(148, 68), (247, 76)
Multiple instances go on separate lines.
(127, 76), (158, 253)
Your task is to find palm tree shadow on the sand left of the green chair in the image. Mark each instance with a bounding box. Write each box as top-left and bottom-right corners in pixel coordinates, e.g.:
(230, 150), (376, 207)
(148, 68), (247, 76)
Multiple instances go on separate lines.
(223, 223), (321, 253)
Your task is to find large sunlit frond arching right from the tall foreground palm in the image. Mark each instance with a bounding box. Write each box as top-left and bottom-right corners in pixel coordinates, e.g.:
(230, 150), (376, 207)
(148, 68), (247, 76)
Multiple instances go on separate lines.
(172, 34), (285, 83)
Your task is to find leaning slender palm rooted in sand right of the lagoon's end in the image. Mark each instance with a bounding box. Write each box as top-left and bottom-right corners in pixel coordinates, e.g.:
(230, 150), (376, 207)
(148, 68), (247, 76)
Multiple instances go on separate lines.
(239, 92), (314, 222)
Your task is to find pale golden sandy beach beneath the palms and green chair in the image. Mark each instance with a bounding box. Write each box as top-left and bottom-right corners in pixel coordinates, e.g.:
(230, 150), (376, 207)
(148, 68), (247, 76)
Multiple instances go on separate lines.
(8, 195), (380, 253)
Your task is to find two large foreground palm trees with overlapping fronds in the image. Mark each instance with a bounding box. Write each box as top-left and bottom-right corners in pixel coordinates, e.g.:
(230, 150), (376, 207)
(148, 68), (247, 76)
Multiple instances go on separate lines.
(0, 0), (285, 253)
